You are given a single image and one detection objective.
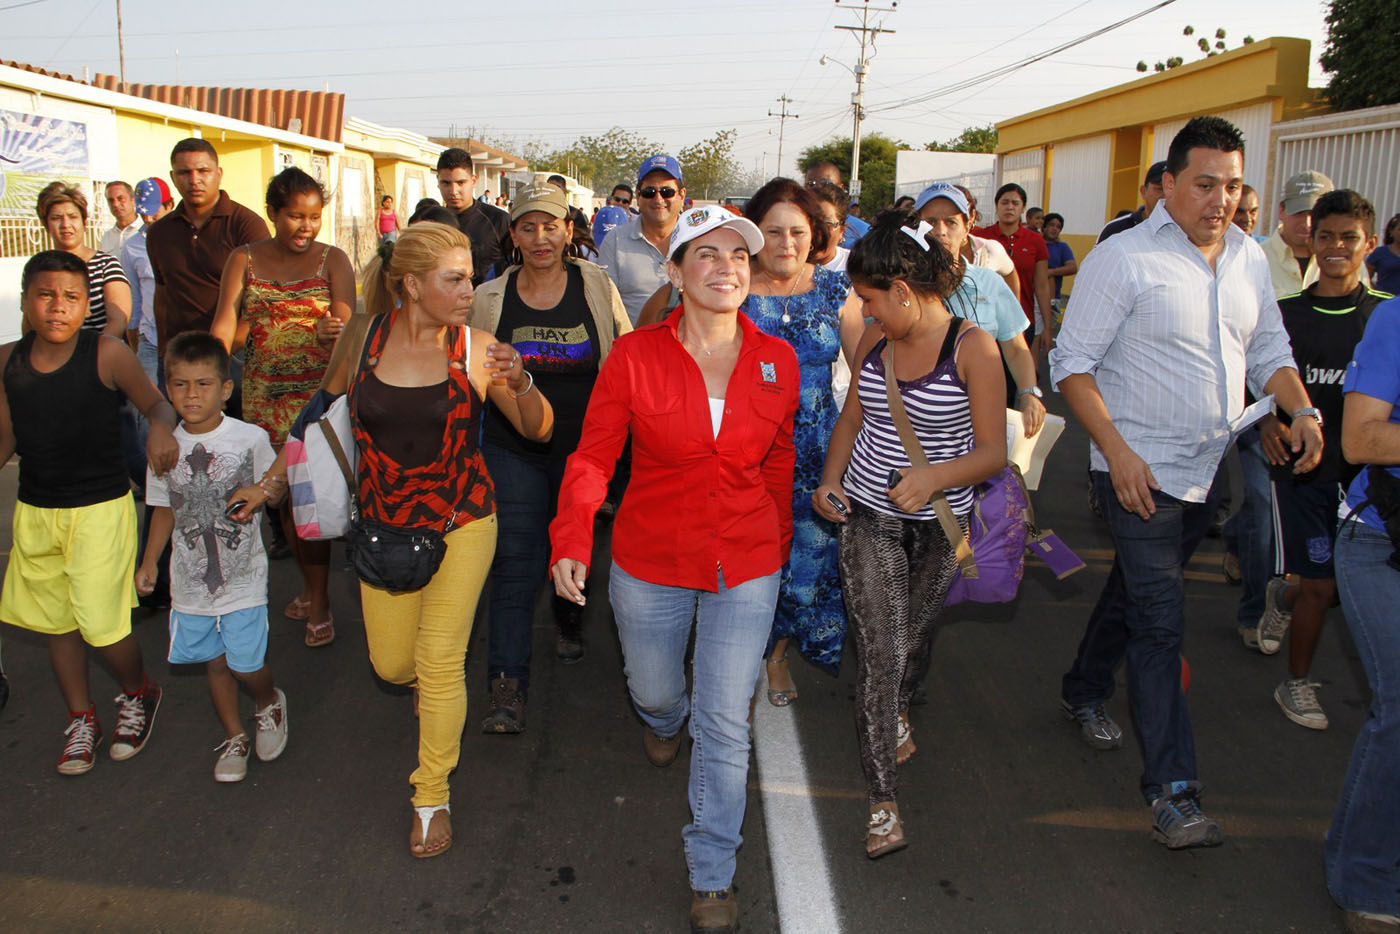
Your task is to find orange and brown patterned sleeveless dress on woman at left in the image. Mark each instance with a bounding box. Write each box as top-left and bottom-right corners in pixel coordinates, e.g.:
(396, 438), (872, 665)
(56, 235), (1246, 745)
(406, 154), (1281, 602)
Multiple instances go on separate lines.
(242, 246), (330, 444)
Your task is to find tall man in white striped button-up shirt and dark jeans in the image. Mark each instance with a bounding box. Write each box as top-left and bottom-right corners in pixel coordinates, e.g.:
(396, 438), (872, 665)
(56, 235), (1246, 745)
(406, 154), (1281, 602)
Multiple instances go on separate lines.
(1050, 116), (1322, 850)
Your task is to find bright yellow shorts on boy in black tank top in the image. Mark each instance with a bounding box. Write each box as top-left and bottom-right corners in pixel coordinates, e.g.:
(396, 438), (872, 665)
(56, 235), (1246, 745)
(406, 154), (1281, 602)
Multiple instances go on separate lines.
(0, 493), (139, 647)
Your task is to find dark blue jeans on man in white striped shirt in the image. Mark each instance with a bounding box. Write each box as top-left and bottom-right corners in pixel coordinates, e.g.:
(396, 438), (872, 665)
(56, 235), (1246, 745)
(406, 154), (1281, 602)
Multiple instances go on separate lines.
(1061, 471), (1218, 804)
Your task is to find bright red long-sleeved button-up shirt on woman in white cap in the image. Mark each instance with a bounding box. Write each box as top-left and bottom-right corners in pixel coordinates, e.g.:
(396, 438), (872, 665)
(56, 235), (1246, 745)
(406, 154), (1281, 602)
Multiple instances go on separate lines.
(549, 305), (799, 592)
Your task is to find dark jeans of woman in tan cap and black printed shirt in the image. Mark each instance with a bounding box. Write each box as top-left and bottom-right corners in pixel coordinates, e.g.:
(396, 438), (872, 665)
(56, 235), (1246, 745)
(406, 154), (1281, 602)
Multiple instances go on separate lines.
(482, 441), (581, 695)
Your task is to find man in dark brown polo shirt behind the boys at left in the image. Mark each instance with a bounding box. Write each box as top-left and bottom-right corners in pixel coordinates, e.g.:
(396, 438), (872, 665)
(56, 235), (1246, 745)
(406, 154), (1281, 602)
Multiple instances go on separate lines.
(146, 137), (270, 364)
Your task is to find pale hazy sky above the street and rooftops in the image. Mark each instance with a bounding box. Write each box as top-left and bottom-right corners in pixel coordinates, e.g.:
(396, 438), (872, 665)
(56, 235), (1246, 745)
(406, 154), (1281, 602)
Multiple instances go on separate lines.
(0, 0), (1326, 184)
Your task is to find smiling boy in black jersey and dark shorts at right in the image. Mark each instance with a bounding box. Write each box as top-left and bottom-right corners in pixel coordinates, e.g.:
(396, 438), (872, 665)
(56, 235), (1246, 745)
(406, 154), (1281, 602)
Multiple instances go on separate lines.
(1259, 189), (1390, 730)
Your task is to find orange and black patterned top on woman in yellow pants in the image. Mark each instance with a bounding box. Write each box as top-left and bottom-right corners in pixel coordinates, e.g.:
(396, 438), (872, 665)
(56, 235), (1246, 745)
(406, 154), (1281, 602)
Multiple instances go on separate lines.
(350, 309), (496, 531)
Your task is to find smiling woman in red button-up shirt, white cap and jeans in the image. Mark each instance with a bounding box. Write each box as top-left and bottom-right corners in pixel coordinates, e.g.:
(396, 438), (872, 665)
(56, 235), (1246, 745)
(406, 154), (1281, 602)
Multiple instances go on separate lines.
(550, 206), (799, 928)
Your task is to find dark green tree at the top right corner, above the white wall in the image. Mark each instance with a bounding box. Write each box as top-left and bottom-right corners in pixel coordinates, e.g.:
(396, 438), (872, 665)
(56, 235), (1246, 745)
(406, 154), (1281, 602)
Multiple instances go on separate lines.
(1320, 0), (1400, 111)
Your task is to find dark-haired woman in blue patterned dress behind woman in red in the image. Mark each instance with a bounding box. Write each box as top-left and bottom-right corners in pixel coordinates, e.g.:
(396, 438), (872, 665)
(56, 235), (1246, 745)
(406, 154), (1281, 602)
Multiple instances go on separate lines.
(742, 178), (862, 707)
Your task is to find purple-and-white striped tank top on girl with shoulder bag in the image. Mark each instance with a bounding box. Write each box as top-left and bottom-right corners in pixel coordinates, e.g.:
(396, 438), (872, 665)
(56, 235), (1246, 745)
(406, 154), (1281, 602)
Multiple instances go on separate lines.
(841, 318), (973, 521)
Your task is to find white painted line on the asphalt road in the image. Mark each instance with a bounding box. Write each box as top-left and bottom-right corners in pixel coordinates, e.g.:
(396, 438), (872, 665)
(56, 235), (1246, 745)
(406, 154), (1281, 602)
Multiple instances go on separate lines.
(753, 678), (841, 934)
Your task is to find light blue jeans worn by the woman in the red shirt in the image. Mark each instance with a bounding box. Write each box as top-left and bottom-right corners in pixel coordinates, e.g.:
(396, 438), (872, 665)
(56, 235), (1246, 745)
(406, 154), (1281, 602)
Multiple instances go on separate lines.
(608, 563), (780, 892)
